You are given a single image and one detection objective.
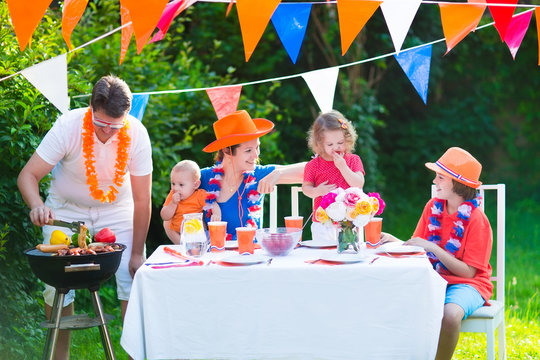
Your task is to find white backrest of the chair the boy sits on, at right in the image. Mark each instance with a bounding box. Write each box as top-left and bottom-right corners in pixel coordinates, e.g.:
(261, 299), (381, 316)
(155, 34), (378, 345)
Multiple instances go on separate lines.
(431, 184), (506, 304)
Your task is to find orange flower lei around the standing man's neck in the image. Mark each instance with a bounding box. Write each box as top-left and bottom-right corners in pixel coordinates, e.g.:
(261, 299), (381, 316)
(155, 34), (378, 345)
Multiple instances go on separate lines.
(82, 108), (131, 203)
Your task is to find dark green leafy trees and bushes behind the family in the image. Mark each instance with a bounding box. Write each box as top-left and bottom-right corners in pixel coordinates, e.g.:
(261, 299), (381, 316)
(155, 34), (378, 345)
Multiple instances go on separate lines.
(0, 0), (540, 358)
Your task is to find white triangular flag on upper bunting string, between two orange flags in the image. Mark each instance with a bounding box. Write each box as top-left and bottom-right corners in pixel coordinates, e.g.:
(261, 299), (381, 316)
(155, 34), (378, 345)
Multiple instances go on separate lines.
(381, 0), (422, 54)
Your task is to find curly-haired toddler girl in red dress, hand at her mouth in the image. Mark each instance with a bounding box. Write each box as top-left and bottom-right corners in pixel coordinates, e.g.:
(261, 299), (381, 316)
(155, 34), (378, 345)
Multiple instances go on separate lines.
(302, 110), (364, 236)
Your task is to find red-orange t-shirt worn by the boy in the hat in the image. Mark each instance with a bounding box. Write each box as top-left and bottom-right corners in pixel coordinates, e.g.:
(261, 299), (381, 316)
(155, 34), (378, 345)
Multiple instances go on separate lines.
(413, 199), (493, 302)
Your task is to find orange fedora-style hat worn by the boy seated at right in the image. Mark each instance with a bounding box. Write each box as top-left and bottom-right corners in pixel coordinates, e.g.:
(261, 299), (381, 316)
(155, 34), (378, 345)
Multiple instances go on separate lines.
(426, 147), (482, 189)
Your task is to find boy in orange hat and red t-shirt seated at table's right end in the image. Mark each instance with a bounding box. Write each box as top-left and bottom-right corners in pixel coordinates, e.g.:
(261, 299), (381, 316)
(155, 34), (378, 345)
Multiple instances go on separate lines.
(381, 147), (493, 360)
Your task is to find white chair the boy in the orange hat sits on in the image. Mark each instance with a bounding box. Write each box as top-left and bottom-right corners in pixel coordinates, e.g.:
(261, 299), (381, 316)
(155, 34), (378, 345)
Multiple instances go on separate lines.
(431, 184), (506, 360)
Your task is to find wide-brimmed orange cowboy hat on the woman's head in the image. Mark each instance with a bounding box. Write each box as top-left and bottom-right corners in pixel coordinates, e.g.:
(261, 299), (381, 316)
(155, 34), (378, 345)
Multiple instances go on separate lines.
(203, 110), (274, 152)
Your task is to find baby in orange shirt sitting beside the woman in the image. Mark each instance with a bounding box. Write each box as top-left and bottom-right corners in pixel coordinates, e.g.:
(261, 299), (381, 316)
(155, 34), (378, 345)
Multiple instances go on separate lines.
(160, 160), (221, 244)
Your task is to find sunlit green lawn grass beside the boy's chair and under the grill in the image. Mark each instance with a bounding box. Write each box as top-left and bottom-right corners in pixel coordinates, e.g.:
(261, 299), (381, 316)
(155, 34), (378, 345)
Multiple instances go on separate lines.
(36, 201), (540, 360)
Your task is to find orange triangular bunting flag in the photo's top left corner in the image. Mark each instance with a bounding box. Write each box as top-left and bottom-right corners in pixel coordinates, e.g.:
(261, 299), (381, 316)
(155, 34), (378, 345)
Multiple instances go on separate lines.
(7, 0), (52, 51)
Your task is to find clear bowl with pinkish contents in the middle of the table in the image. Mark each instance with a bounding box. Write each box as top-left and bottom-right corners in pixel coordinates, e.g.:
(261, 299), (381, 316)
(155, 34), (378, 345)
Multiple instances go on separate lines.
(255, 227), (302, 256)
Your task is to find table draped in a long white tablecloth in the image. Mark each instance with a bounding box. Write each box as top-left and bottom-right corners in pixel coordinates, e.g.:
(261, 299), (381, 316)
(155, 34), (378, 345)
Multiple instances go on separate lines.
(120, 246), (446, 360)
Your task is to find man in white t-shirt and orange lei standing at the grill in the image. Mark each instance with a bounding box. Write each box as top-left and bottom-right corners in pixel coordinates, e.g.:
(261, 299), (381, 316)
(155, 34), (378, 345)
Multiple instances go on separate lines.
(17, 75), (152, 359)
